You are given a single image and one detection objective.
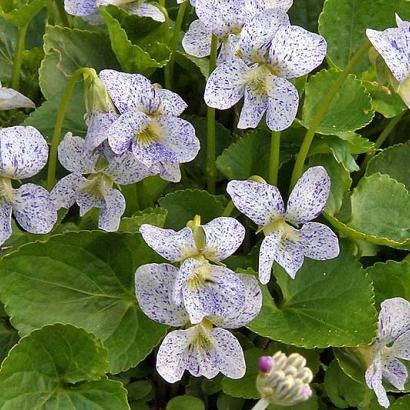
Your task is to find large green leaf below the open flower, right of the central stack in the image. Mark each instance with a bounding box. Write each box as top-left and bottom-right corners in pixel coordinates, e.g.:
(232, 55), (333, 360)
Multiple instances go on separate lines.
(248, 248), (376, 348)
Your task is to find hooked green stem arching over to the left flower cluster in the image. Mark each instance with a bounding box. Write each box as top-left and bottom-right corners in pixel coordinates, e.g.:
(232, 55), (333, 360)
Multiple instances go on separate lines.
(47, 68), (95, 191)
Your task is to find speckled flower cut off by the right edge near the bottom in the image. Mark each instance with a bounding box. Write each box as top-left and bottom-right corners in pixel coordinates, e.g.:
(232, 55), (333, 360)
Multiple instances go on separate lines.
(366, 298), (410, 408)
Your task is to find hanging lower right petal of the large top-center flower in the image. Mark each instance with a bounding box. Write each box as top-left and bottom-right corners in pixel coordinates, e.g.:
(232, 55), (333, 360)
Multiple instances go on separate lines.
(266, 75), (299, 131)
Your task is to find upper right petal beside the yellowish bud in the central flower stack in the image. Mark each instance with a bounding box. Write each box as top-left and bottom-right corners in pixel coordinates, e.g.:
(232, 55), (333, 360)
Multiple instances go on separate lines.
(202, 217), (245, 262)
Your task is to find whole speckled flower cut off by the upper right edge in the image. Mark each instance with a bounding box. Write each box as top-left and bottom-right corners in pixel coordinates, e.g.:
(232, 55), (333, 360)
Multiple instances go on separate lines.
(366, 15), (410, 108)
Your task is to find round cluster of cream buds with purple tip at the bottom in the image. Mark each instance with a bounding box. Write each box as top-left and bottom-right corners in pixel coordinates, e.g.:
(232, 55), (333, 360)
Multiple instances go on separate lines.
(256, 351), (313, 406)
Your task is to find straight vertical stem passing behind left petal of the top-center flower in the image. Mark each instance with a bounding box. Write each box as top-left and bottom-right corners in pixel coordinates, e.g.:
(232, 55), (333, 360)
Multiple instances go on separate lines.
(207, 35), (218, 194)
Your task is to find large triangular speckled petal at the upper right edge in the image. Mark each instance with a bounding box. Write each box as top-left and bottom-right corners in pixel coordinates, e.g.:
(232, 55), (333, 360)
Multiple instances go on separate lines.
(366, 28), (410, 82)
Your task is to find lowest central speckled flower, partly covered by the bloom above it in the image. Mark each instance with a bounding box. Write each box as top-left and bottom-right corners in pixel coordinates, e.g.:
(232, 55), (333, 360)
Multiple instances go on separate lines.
(135, 264), (262, 383)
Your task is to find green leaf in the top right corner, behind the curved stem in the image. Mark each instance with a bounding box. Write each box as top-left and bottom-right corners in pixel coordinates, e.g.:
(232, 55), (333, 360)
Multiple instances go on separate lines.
(319, 0), (410, 70)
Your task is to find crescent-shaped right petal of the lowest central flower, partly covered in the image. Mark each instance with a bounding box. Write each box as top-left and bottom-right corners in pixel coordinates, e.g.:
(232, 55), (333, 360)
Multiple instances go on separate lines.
(212, 273), (262, 329)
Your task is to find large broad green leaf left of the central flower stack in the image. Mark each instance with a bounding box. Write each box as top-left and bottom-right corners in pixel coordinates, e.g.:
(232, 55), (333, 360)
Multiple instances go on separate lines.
(0, 231), (166, 373)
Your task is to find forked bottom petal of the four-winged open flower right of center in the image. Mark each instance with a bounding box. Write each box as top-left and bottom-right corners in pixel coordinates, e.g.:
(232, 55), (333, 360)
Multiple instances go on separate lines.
(259, 228), (303, 284)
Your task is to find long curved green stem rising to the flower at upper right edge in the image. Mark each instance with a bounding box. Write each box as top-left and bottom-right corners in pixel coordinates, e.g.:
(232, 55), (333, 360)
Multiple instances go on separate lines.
(290, 42), (370, 189)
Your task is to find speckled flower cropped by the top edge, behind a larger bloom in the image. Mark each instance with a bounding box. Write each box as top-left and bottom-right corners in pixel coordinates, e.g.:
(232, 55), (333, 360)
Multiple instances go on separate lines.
(182, 0), (292, 63)
